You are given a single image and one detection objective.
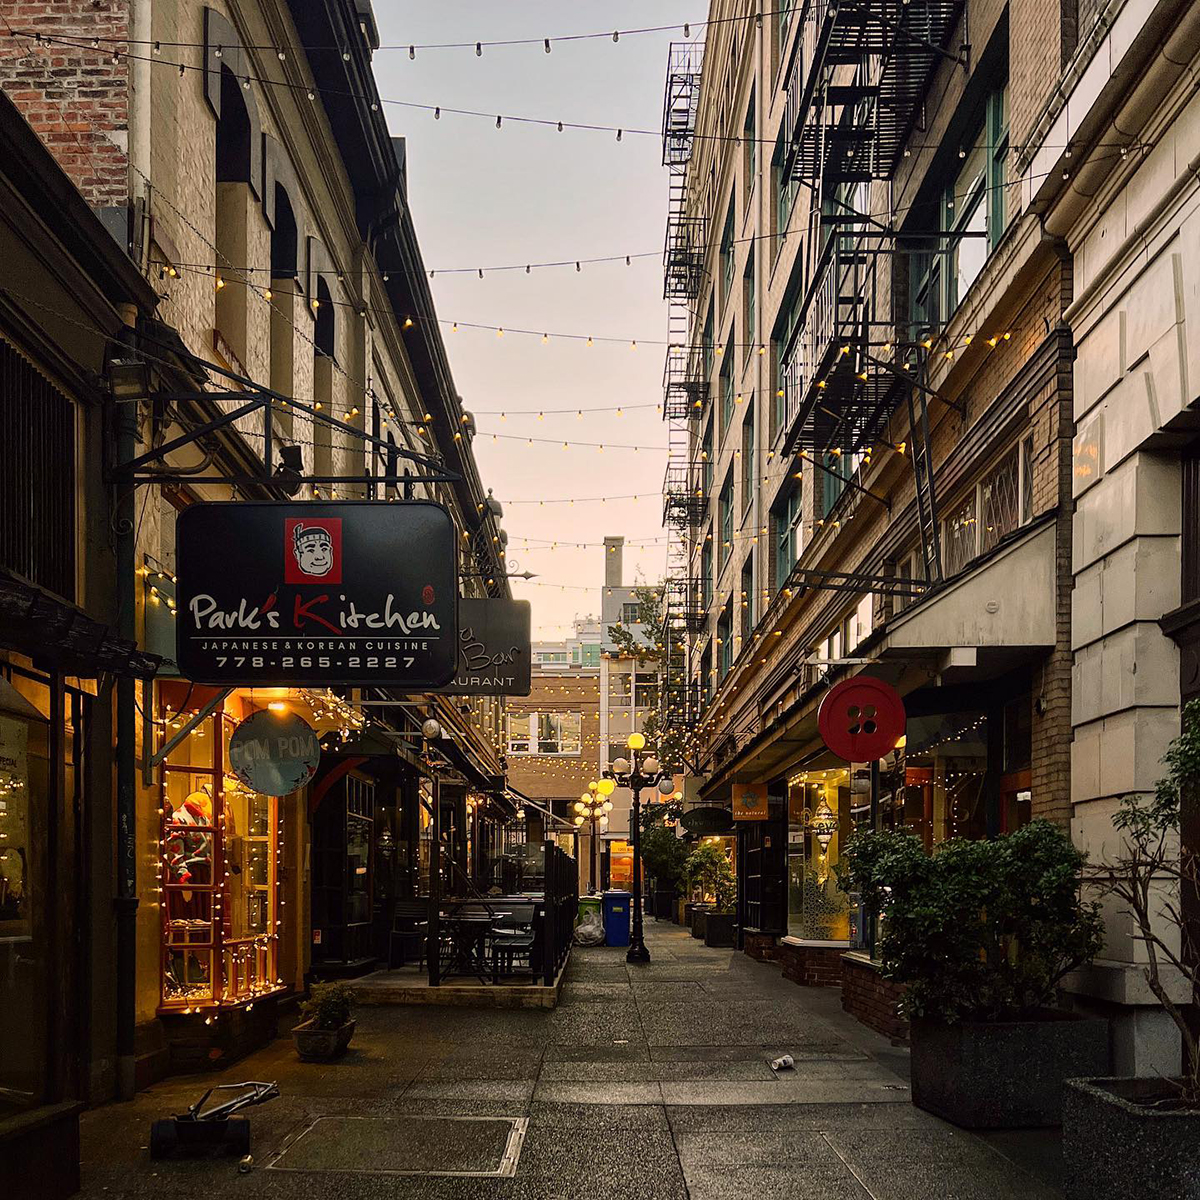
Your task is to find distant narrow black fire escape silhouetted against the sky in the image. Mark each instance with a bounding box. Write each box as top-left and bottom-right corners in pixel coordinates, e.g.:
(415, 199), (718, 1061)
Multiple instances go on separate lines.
(661, 42), (708, 728)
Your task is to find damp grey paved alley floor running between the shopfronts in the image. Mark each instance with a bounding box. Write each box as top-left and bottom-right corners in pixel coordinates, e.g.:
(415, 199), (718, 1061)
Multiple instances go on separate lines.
(83, 920), (1058, 1200)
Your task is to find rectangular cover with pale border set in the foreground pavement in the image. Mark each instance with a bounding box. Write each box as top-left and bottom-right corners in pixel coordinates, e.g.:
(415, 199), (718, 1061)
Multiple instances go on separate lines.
(269, 1116), (528, 1176)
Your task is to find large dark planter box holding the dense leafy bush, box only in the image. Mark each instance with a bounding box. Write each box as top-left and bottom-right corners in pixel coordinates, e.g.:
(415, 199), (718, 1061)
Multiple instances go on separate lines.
(911, 1010), (1109, 1129)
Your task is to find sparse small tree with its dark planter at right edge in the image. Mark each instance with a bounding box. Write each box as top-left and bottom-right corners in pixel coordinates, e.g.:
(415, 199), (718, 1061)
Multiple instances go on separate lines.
(1062, 701), (1200, 1200)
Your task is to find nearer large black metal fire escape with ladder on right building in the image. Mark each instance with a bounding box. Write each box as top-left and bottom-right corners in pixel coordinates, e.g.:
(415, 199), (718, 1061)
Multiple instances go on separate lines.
(784, 0), (962, 582)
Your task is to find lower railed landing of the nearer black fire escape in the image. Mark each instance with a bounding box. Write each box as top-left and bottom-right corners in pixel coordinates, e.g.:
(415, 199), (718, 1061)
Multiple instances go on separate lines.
(782, 238), (902, 452)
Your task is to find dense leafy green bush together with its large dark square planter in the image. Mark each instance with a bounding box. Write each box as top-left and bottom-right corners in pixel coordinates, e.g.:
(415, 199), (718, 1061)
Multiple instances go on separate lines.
(840, 821), (1109, 1129)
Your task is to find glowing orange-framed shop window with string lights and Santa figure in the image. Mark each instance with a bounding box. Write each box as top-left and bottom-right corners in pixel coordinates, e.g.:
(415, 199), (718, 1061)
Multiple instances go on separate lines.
(158, 707), (283, 1012)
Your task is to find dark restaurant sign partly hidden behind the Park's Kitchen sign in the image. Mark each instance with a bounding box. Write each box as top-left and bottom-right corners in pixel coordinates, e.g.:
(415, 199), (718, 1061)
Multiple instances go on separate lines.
(437, 598), (533, 696)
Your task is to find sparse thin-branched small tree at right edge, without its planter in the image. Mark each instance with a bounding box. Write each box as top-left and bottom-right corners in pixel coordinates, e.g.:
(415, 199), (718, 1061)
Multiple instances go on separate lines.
(1094, 700), (1200, 1106)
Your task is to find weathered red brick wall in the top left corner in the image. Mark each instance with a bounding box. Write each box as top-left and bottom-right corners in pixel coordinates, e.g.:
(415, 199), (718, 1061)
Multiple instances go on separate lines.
(0, 0), (130, 208)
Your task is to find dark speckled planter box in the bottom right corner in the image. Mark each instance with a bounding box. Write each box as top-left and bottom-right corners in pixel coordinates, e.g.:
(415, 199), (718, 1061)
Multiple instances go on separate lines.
(1062, 1079), (1200, 1200)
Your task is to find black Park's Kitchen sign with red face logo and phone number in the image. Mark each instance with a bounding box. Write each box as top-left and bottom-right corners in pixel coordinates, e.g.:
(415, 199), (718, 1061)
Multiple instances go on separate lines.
(175, 500), (458, 690)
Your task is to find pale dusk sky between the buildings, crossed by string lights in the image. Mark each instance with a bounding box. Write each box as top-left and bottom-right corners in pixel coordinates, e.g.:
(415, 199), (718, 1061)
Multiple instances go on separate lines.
(374, 0), (708, 640)
